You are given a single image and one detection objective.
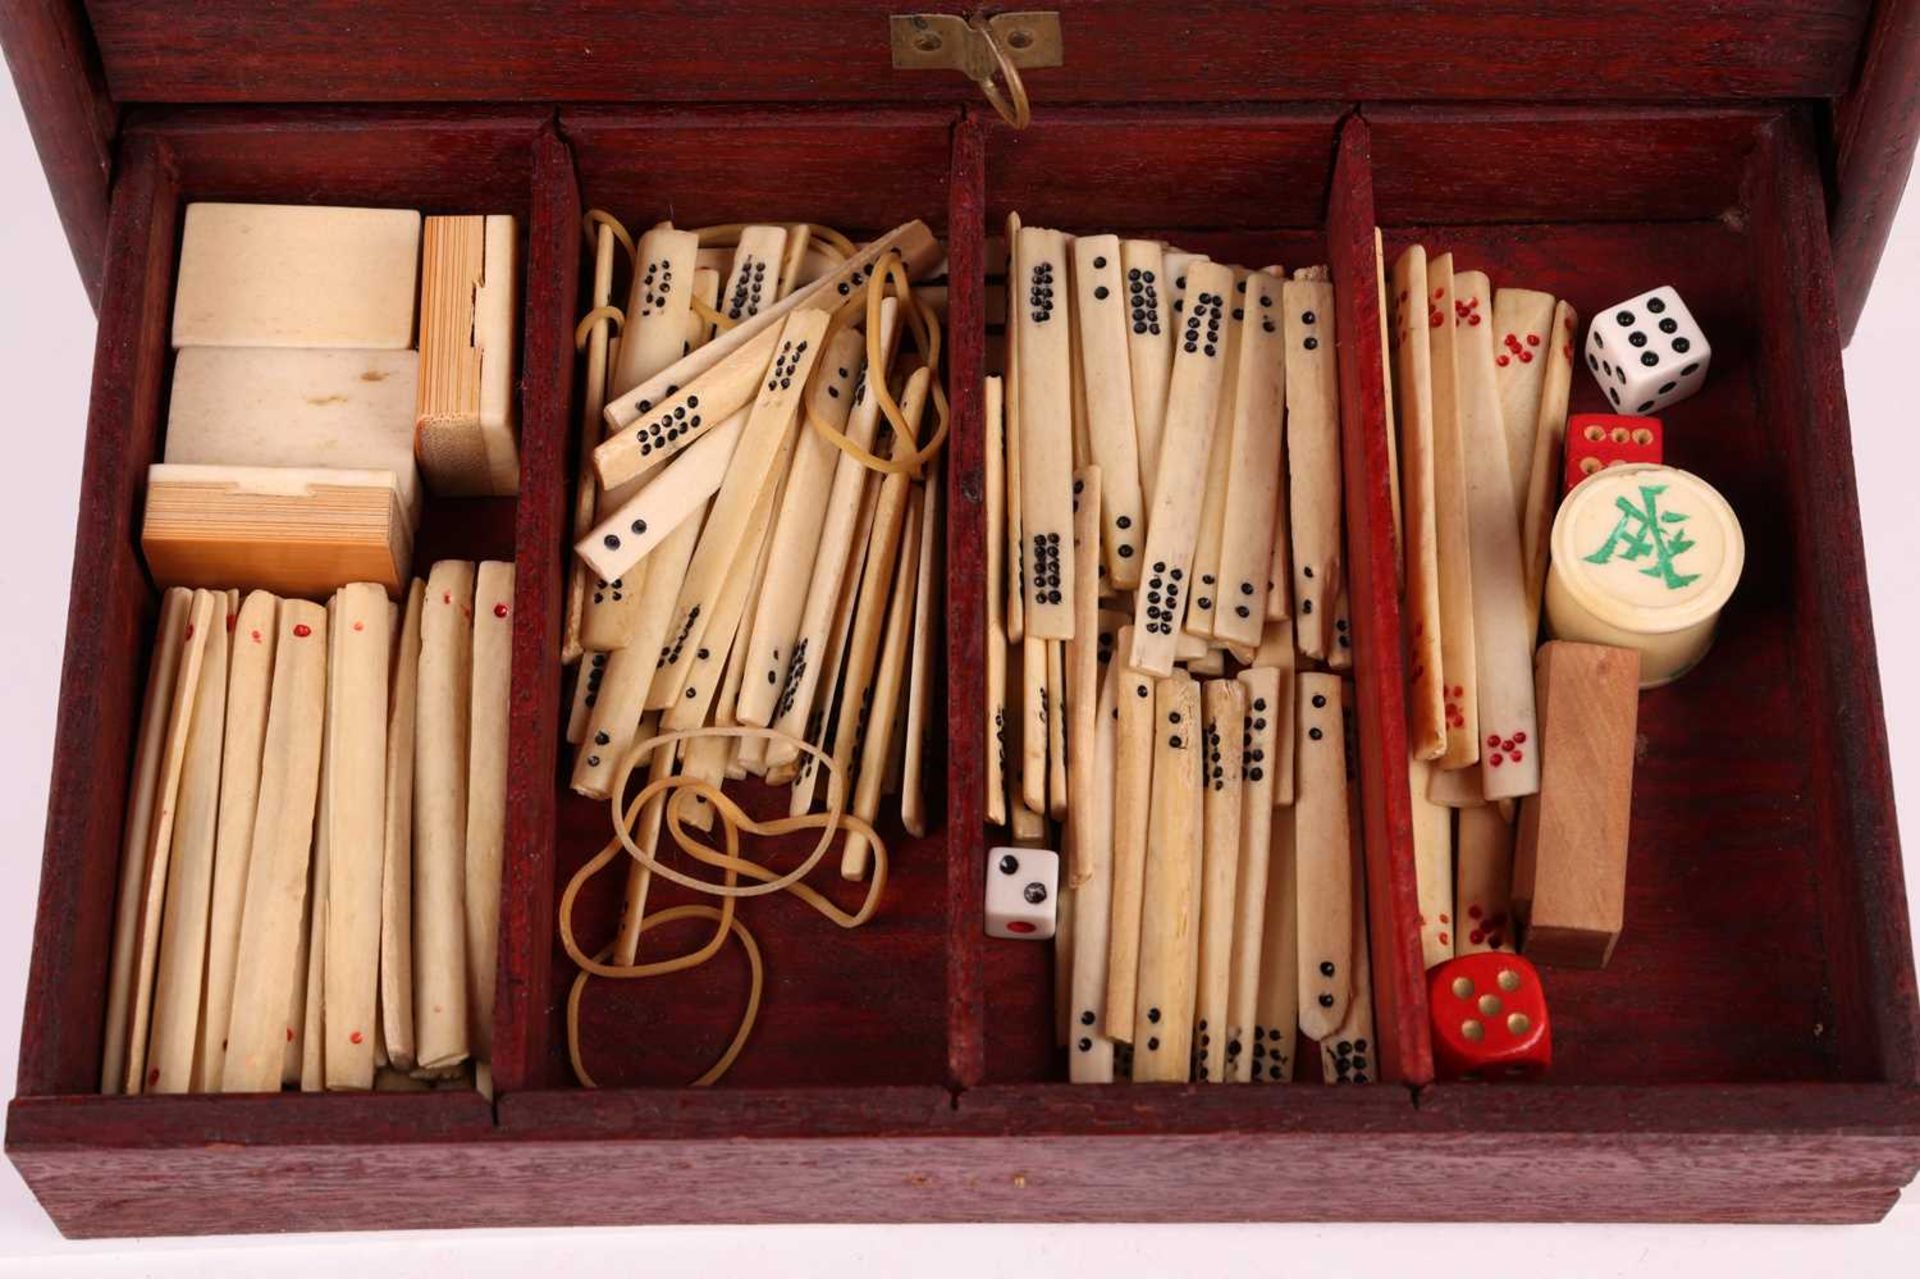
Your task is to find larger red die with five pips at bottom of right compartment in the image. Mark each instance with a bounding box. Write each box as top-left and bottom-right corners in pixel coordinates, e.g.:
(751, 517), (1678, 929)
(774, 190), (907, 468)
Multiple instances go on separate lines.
(1427, 951), (1553, 1079)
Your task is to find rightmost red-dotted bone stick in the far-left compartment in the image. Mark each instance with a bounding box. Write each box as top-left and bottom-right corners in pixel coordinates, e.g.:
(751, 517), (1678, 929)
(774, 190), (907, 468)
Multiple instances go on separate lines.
(466, 561), (513, 1070)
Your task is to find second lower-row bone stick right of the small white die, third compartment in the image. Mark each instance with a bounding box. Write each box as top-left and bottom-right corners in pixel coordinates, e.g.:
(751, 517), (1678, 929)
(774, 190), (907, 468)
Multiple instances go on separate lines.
(1106, 626), (1156, 1043)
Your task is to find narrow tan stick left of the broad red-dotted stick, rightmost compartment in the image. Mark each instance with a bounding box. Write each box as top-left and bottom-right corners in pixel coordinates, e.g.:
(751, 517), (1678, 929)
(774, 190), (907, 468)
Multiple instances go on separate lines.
(1427, 253), (1480, 768)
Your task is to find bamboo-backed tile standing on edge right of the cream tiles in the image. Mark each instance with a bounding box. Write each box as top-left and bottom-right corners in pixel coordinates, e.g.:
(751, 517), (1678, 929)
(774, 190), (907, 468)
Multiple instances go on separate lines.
(413, 215), (520, 497)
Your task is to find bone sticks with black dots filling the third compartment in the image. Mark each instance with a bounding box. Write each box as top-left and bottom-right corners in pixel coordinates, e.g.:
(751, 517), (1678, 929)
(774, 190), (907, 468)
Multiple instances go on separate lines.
(985, 215), (1374, 1083)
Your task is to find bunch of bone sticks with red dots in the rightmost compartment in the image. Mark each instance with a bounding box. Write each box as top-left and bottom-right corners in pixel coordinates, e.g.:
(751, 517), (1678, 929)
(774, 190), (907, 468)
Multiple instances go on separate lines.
(1394, 244), (1578, 968)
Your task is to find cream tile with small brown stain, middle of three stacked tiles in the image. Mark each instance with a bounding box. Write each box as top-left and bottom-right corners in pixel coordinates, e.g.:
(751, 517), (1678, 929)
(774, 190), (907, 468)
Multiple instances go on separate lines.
(161, 346), (420, 513)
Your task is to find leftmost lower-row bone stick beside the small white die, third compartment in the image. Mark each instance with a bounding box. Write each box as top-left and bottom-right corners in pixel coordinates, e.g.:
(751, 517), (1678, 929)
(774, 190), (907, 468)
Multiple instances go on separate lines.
(1068, 652), (1131, 1083)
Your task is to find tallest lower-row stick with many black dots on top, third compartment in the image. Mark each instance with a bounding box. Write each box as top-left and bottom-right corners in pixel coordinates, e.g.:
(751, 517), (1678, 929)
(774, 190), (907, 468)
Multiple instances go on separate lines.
(1221, 666), (1290, 1083)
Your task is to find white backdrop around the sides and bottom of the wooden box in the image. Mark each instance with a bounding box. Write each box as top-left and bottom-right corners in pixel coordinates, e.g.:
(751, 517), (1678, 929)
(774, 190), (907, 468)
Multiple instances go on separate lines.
(0, 77), (1920, 1279)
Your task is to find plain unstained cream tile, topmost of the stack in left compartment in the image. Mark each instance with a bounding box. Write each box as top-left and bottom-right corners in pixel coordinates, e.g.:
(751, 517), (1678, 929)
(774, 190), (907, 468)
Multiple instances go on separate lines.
(173, 204), (420, 351)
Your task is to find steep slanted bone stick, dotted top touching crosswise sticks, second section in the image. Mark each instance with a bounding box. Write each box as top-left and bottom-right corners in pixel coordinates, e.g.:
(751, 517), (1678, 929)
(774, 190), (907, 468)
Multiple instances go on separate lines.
(655, 311), (828, 701)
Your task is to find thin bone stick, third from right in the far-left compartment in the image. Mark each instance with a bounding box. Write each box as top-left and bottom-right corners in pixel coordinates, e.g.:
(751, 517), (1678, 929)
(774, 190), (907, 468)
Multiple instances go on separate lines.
(374, 578), (426, 1070)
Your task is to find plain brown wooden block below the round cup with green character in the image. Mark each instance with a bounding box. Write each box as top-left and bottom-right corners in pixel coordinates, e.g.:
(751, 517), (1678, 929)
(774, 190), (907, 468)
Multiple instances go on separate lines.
(1513, 641), (1640, 968)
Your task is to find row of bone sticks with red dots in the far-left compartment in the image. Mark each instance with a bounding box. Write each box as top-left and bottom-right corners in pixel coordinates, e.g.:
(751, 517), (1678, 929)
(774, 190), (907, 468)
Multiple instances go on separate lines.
(109, 565), (511, 1093)
